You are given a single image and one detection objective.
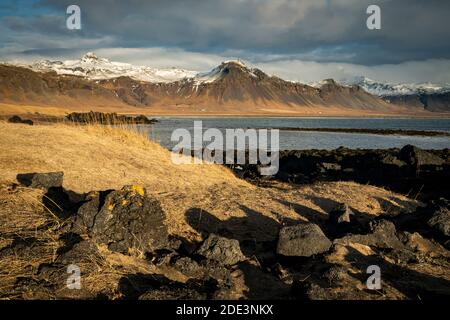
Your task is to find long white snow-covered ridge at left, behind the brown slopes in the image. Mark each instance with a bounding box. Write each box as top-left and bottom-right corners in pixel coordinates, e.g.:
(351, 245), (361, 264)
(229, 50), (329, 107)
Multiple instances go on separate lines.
(28, 52), (197, 83)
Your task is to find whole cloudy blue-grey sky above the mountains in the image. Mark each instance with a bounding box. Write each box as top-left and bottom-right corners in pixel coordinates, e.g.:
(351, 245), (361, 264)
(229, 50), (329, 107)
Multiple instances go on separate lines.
(0, 0), (450, 84)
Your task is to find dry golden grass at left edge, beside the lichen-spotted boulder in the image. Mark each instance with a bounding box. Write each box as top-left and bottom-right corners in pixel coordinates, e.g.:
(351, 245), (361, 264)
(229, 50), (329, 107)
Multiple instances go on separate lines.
(0, 185), (60, 298)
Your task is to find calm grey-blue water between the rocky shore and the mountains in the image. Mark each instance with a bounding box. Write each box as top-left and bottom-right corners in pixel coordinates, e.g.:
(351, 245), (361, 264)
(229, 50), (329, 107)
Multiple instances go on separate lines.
(144, 117), (450, 150)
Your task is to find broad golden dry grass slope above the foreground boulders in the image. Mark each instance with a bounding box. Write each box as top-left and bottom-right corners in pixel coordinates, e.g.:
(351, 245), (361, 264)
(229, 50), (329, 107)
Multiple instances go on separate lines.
(0, 122), (417, 239)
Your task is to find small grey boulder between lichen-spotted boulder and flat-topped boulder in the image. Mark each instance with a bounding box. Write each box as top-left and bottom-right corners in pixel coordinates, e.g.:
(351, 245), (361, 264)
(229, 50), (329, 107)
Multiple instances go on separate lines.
(197, 233), (246, 265)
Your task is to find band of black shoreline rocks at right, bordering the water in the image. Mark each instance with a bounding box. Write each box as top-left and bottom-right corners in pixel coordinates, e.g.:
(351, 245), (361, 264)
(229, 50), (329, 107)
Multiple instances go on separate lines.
(233, 145), (450, 199)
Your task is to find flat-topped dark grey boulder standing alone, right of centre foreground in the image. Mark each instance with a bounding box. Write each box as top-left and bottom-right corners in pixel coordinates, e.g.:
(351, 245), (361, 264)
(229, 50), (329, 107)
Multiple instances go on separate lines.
(277, 223), (331, 257)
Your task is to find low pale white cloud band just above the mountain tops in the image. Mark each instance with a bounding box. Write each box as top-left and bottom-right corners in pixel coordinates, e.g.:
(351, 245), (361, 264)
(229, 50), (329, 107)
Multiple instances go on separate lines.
(0, 48), (450, 84)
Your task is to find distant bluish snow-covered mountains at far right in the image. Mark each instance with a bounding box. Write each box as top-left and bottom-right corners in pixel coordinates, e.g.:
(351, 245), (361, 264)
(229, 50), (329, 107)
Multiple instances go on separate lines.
(341, 77), (450, 97)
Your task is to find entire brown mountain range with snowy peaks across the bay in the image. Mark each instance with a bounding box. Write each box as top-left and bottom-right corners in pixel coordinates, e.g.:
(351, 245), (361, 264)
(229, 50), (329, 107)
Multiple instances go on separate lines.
(0, 53), (450, 115)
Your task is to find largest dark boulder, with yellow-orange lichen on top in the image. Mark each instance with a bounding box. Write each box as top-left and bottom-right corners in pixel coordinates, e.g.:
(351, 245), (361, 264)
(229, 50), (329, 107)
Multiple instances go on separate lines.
(74, 186), (168, 253)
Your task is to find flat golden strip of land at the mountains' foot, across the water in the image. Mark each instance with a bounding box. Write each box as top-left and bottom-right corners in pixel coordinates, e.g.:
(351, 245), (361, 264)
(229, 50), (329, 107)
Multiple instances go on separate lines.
(0, 97), (442, 118)
